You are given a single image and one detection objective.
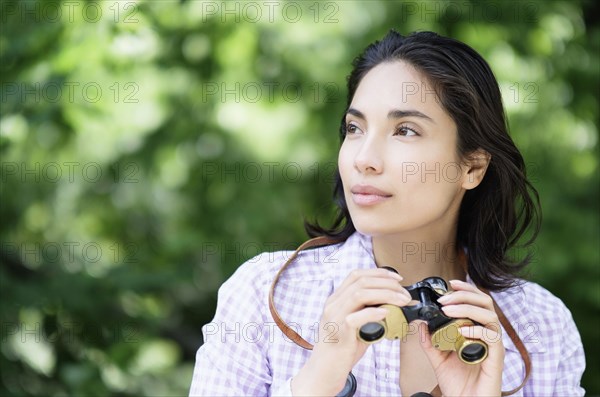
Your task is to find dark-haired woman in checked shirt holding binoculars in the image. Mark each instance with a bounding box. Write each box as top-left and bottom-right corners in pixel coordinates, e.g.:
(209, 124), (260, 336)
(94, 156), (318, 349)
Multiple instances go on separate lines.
(190, 31), (585, 396)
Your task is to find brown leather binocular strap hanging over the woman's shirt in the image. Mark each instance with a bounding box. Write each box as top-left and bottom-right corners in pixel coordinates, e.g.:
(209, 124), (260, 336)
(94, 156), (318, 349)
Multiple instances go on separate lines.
(269, 236), (531, 397)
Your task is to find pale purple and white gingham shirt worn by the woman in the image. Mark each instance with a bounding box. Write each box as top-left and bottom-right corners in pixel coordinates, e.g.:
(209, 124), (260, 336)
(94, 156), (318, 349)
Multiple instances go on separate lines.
(190, 232), (585, 397)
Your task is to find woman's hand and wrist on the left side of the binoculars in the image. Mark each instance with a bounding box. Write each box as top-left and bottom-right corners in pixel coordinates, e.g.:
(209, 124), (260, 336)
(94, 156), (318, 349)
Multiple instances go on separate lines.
(292, 269), (411, 396)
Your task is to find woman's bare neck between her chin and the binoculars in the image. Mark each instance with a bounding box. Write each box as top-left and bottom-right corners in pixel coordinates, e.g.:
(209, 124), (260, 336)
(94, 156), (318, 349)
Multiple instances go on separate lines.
(373, 234), (466, 285)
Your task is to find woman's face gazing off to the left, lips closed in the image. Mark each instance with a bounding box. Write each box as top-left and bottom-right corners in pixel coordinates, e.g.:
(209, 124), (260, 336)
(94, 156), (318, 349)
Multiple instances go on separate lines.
(338, 61), (473, 237)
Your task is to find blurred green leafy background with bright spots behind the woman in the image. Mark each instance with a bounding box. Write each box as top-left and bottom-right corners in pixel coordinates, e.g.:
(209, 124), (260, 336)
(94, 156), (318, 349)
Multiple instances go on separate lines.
(0, 0), (600, 396)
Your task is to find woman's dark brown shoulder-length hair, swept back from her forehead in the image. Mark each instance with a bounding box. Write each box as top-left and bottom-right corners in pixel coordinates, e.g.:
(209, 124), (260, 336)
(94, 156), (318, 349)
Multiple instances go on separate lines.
(305, 30), (541, 291)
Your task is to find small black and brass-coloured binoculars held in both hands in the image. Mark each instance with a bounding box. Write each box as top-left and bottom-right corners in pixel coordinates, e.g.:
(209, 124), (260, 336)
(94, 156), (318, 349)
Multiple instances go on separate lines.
(358, 268), (488, 364)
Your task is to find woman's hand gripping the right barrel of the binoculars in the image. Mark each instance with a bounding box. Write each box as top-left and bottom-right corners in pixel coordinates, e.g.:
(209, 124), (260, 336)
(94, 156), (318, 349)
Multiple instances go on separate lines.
(419, 280), (504, 396)
